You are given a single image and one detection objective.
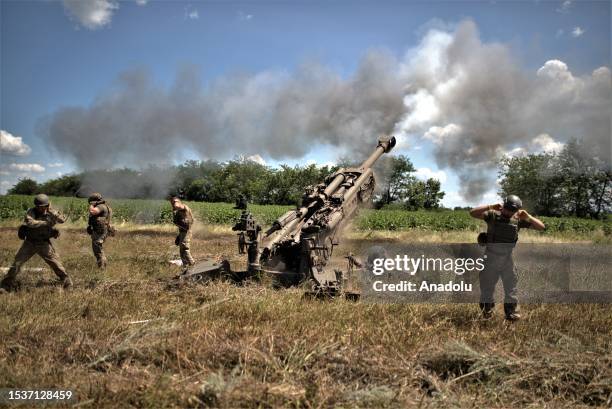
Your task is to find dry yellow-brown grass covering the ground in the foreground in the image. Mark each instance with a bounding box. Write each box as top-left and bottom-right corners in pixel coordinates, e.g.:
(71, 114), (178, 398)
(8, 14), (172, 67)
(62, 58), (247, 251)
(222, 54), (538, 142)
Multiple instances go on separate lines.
(0, 226), (612, 408)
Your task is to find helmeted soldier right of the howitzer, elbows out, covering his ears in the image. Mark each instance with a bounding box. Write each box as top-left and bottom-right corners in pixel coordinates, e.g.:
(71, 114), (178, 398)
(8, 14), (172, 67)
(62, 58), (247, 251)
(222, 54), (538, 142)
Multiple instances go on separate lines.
(470, 195), (545, 321)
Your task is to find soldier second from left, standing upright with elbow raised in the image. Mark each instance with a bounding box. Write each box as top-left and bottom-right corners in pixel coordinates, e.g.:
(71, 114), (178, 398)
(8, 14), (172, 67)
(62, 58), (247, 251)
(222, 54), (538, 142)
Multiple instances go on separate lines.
(87, 193), (114, 269)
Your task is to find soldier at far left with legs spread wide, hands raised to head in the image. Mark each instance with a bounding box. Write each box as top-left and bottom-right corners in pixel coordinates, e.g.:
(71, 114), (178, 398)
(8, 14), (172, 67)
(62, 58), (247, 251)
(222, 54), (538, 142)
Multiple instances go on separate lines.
(0, 194), (72, 290)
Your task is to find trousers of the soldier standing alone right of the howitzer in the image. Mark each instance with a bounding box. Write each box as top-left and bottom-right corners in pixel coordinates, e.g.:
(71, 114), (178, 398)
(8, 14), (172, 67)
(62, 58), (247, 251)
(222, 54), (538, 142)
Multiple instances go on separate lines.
(479, 252), (518, 314)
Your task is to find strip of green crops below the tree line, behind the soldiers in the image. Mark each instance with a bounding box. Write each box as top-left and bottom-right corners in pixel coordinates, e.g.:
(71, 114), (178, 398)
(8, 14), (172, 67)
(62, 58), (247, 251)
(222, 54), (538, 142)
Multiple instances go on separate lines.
(0, 195), (612, 236)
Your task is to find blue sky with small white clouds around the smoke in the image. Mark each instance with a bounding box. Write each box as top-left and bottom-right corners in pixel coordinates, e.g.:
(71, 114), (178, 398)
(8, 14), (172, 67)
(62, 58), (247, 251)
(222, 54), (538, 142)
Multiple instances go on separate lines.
(0, 0), (610, 205)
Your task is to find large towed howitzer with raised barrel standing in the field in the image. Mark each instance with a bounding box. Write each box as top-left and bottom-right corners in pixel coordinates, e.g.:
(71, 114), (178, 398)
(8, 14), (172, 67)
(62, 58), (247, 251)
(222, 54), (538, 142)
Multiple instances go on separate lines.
(186, 136), (395, 295)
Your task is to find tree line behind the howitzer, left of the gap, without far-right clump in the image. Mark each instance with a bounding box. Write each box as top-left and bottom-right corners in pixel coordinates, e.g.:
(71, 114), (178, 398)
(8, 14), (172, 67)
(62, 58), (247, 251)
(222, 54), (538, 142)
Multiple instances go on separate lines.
(8, 156), (444, 210)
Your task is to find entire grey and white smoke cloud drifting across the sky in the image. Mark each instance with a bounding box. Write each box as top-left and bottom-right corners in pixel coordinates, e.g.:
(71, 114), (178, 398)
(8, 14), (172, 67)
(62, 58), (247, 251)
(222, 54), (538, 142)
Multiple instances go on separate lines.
(40, 21), (612, 200)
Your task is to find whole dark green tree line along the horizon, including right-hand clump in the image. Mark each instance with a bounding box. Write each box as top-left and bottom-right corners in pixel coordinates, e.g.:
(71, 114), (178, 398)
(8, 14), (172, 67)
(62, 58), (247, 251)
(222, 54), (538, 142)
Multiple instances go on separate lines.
(9, 141), (612, 218)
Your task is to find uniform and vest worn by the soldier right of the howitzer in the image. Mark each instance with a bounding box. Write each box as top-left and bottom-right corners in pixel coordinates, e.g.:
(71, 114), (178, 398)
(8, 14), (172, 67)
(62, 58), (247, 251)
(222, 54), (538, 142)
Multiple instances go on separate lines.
(479, 210), (531, 316)
